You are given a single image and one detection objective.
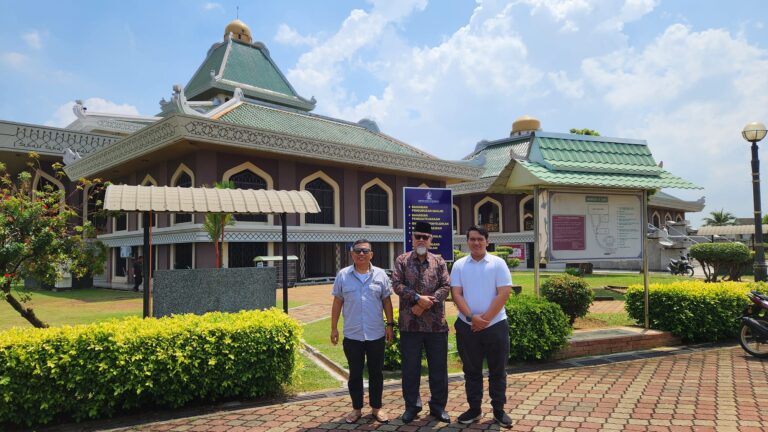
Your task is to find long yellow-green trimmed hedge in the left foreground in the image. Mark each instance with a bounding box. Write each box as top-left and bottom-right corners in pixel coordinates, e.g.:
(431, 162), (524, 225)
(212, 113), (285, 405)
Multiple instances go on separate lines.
(0, 309), (301, 425)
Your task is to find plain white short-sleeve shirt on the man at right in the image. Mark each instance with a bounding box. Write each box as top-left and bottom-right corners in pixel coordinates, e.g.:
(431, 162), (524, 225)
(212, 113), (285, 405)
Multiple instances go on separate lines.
(451, 253), (512, 325)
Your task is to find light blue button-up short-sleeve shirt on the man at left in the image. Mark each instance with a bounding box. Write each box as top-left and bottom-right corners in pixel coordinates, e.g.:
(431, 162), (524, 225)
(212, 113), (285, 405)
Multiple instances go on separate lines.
(331, 265), (392, 341)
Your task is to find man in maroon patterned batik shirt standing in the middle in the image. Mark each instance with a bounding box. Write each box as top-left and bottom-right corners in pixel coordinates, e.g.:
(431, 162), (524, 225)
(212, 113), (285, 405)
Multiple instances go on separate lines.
(392, 222), (451, 423)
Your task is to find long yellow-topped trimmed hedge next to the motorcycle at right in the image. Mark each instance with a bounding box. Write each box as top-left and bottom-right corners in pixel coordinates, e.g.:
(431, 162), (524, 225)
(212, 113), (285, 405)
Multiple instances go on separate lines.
(625, 281), (756, 342)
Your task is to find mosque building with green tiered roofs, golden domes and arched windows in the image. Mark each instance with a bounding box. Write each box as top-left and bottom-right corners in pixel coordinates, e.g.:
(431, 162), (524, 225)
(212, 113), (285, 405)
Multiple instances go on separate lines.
(0, 20), (704, 288)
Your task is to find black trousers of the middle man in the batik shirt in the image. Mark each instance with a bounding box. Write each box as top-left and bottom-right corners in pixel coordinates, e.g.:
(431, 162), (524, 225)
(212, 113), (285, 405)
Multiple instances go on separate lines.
(400, 332), (448, 410)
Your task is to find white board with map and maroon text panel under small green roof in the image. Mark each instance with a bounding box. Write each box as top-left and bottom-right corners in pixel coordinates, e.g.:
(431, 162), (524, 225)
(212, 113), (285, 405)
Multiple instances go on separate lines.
(549, 192), (643, 261)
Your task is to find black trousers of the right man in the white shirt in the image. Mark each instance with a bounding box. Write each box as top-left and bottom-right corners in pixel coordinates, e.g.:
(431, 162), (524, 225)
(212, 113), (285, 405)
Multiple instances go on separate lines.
(454, 318), (509, 410)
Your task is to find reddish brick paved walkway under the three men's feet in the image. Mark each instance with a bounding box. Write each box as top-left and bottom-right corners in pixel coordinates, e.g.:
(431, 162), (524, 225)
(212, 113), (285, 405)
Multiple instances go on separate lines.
(115, 347), (768, 432)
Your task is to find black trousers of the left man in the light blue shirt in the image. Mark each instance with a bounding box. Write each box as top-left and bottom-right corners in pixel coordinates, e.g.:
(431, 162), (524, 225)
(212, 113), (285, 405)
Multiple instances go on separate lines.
(342, 338), (384, 409)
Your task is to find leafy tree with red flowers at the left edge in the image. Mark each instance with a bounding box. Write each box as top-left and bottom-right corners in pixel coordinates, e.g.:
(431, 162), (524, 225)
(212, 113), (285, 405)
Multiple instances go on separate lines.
(0, 153), (106, 327)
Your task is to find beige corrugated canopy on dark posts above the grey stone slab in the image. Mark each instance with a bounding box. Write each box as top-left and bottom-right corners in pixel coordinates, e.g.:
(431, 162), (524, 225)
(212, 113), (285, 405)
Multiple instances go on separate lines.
(104, 185), (320, 317)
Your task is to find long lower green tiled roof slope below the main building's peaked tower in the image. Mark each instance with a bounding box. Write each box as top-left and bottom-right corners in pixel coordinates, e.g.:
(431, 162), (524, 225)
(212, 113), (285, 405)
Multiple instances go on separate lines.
(219, 102), (432, 158)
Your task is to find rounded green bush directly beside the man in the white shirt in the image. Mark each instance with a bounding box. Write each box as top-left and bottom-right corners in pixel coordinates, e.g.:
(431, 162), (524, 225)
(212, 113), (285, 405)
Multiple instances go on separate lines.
(505, 294), (572, 360)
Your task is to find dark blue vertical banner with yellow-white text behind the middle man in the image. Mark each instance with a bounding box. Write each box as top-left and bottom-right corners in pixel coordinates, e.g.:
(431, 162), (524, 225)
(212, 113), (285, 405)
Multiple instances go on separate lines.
(403, 188), (453, 261)
